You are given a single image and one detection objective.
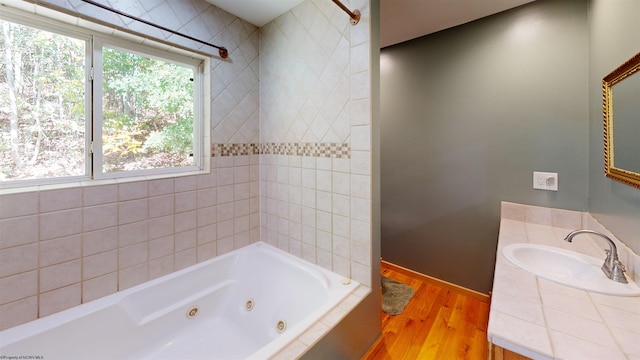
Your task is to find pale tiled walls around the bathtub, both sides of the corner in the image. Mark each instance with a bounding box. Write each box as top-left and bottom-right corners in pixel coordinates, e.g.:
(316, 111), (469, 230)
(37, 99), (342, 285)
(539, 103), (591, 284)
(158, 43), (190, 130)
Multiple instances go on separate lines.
(0, 0), (371, 329)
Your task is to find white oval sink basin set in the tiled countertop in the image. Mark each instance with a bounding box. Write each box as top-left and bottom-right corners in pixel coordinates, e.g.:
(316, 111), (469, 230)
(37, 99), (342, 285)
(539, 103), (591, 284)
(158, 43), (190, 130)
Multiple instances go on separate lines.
(502, 243), (640, 296)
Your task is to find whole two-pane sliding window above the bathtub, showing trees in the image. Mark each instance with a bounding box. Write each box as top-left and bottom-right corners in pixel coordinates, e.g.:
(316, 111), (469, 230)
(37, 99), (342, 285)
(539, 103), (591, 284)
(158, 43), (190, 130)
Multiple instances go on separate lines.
(0, 11), (206, 187)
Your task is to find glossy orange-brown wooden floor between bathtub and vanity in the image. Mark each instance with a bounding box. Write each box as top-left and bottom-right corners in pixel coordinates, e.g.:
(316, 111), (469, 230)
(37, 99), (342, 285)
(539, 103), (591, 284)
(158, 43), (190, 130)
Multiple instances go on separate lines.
(363, 263), (489, 360)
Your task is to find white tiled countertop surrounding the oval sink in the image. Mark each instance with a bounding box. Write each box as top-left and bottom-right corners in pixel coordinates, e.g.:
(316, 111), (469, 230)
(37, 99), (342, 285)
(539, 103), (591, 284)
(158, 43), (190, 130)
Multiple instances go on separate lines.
(487, 203), (640, 360)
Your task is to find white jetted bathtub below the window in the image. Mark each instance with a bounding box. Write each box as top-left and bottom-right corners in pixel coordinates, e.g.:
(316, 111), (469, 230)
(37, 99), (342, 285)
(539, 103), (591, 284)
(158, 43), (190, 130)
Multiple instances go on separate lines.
(0, 243), (358, 360)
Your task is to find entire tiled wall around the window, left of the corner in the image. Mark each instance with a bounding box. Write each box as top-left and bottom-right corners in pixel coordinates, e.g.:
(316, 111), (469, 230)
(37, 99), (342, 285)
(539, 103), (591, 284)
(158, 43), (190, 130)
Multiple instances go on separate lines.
(0, 0), (260, 329)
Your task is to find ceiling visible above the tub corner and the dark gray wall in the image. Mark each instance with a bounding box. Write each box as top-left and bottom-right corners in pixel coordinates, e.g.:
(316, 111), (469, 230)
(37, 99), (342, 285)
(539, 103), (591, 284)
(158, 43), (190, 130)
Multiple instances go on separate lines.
(206, 0), (533, 47)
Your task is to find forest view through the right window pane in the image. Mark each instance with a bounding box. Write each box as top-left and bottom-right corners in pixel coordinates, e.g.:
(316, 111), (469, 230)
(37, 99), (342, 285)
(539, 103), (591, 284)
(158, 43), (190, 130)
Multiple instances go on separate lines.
(102, 47), (195, 172)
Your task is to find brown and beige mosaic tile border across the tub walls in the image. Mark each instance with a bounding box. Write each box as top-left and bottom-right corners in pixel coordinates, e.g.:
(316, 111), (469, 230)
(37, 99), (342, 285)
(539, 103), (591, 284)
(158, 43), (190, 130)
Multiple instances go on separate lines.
(211, 143), (351, 159)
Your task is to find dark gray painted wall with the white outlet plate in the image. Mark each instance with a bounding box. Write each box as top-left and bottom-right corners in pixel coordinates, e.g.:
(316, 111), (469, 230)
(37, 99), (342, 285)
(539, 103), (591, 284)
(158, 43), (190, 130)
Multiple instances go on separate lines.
(380, 0), (592, 293)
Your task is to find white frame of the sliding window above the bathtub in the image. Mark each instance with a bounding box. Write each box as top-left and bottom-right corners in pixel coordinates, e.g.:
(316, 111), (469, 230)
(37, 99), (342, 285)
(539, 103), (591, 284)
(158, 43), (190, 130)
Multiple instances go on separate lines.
(0, 6), (211, 193)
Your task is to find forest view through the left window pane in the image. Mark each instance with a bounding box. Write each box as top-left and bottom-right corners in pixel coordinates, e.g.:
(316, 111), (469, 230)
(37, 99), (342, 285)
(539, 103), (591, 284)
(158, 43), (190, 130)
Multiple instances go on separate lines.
(0, 20), (87, 181)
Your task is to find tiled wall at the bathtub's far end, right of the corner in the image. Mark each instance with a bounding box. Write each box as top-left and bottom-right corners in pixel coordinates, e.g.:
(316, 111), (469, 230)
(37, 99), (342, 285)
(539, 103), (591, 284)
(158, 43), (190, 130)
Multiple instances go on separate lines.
(260, 0), (371, 286)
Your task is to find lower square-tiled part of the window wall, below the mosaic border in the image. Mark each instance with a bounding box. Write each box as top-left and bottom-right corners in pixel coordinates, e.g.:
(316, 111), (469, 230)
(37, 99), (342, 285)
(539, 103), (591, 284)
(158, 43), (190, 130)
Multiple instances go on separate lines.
(0, 162), (259, 329)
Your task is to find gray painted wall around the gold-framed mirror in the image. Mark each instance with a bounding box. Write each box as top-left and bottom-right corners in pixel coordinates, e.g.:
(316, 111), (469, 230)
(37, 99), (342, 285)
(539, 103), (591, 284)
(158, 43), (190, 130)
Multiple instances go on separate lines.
(589, 0), (640, 253)
